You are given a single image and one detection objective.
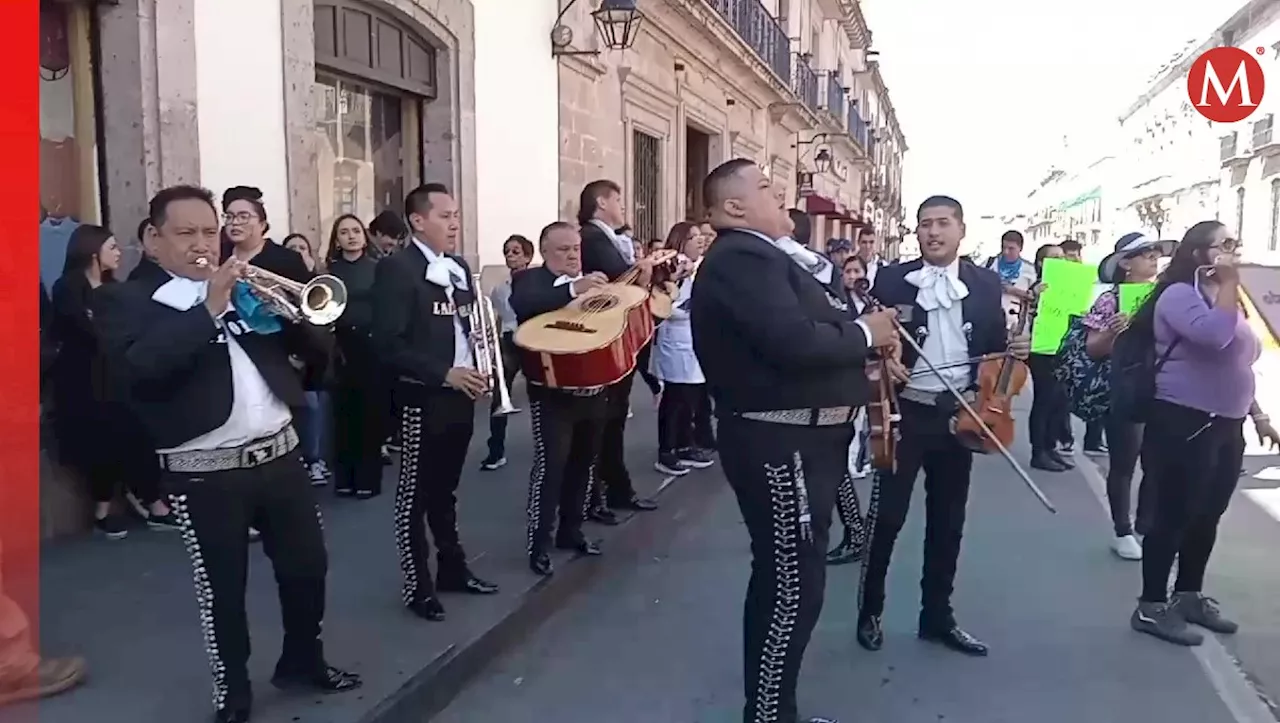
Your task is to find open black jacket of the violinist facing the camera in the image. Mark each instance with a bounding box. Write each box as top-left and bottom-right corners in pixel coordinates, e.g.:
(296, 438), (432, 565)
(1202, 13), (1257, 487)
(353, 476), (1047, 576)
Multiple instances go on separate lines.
(872, 258), (1009, 379)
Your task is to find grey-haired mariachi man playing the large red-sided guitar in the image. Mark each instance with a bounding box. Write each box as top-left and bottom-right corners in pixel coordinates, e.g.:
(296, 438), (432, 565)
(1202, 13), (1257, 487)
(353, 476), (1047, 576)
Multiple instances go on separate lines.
(511, 221), (608, 576)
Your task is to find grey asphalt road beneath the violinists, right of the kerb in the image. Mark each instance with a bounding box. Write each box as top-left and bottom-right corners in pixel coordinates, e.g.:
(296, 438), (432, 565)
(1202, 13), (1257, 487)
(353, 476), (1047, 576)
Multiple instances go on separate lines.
(434, 394), (1280, 723)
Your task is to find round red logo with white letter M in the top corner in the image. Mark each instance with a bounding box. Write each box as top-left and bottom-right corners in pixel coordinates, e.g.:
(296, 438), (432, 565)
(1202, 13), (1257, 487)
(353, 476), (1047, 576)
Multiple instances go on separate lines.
(1187, 47), (1266, 123)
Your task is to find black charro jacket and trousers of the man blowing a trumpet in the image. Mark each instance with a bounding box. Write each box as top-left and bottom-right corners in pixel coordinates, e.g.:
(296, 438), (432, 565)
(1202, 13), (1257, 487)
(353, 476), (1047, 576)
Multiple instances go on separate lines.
(95, 273), (360, 722)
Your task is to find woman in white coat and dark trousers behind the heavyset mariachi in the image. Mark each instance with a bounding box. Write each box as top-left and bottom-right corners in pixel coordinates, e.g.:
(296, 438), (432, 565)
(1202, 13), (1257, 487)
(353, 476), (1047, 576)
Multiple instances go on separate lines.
(650, 221), (716, 476)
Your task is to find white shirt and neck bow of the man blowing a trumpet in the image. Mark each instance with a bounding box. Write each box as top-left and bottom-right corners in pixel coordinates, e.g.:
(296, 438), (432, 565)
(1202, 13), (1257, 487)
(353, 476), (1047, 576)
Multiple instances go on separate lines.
(151, 276), (293, 454)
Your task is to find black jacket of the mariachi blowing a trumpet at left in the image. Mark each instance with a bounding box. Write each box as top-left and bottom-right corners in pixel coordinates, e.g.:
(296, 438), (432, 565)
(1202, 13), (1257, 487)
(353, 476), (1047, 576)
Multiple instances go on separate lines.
(95, 272), (333, 449)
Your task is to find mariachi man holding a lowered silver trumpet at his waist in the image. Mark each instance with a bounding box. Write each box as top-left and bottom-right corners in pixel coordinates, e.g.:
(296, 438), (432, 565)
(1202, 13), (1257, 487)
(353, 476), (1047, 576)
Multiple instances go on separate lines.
(372, 183), (498, 621)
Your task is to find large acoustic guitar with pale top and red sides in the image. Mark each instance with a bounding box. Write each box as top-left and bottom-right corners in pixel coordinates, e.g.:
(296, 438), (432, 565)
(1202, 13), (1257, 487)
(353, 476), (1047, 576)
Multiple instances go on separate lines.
(513, 251), (675, 389)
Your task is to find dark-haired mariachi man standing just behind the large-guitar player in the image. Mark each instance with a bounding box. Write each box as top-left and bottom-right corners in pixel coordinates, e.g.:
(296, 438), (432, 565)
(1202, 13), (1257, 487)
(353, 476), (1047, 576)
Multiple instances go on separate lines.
(577, 180), (658, 525)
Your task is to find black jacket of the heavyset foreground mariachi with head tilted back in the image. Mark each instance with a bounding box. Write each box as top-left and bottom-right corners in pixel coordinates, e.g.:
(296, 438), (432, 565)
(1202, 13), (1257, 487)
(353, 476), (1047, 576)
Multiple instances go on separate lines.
(690, 229), (869, 416)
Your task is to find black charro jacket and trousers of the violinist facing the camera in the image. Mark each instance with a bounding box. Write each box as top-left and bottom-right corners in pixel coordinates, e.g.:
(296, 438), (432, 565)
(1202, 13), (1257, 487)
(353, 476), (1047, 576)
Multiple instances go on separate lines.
(858, 260), (1009, 655)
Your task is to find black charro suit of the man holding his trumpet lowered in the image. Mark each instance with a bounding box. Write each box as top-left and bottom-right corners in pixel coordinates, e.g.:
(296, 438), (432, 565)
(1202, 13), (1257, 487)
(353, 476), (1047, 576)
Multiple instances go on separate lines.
(372, 242), (497, 609)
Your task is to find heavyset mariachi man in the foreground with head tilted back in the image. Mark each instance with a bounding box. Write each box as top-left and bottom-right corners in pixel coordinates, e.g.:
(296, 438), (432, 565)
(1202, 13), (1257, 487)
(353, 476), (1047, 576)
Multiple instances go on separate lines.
(690, 159), (893, 723)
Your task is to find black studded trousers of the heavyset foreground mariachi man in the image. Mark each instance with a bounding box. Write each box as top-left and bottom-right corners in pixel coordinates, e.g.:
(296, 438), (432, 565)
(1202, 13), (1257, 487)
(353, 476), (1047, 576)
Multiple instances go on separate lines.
(719, 417), (854, 723)
